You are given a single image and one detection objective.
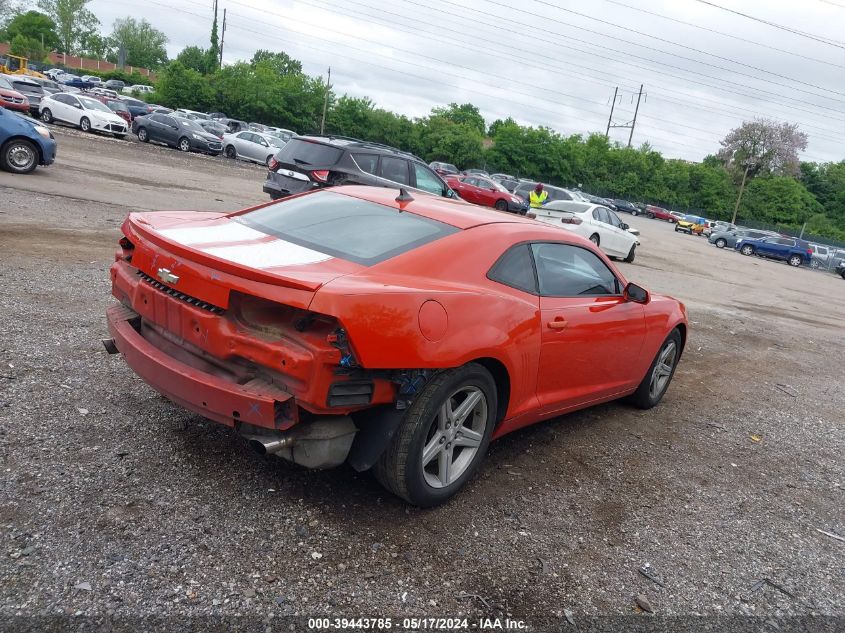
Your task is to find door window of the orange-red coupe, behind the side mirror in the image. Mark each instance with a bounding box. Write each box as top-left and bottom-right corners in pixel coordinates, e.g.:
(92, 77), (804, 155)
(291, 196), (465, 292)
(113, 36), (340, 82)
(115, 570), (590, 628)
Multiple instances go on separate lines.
(531, 243), (621, 297)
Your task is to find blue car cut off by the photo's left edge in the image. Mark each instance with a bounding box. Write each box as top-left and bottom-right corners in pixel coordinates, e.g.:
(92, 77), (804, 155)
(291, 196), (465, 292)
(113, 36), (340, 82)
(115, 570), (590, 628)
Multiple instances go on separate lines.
(0, 108), (56, 174)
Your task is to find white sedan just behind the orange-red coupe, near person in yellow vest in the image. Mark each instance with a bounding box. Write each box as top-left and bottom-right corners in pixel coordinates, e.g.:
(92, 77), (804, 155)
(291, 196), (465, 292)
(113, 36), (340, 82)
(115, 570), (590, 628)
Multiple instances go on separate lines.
(531, 200), (640, 262)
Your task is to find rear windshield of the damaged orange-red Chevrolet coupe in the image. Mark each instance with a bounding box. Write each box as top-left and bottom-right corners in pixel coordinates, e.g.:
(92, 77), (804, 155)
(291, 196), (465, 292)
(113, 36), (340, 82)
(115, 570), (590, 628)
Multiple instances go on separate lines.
(236, 190), (460, 266)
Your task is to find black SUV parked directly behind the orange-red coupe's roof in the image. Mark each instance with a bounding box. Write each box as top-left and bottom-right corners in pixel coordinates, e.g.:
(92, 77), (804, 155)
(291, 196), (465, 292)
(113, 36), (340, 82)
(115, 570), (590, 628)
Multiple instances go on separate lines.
(264, 136), (458, 200)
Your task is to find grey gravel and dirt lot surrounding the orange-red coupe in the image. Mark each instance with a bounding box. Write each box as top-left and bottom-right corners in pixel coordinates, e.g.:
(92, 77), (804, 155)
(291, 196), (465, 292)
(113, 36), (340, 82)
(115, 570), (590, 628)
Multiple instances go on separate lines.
(0, 129), (845, 630)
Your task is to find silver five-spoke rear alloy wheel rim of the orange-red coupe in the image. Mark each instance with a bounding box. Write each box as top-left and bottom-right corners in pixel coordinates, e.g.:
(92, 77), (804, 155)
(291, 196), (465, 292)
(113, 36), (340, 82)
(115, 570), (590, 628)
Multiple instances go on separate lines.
(422, 386), (487, 488)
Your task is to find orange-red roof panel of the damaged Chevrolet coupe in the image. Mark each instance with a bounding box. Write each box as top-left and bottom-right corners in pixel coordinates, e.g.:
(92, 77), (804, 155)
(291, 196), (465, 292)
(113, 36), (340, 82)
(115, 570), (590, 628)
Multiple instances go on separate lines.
(332, 185), (541, 229)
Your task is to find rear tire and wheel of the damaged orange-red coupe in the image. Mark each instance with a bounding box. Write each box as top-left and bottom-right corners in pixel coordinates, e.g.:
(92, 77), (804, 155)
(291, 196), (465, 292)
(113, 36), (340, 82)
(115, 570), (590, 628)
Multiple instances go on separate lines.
(374, 363), (497, 507)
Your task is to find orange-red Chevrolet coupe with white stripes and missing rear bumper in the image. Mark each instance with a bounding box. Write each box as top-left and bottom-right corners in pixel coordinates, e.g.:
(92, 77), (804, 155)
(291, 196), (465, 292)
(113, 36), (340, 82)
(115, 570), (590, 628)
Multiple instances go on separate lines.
(104, 186), (688, 506)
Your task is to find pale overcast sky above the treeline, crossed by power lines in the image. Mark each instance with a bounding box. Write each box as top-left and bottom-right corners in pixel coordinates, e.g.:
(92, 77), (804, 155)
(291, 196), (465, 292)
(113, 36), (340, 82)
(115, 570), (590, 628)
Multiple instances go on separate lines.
(89, 0), (845, 161)
